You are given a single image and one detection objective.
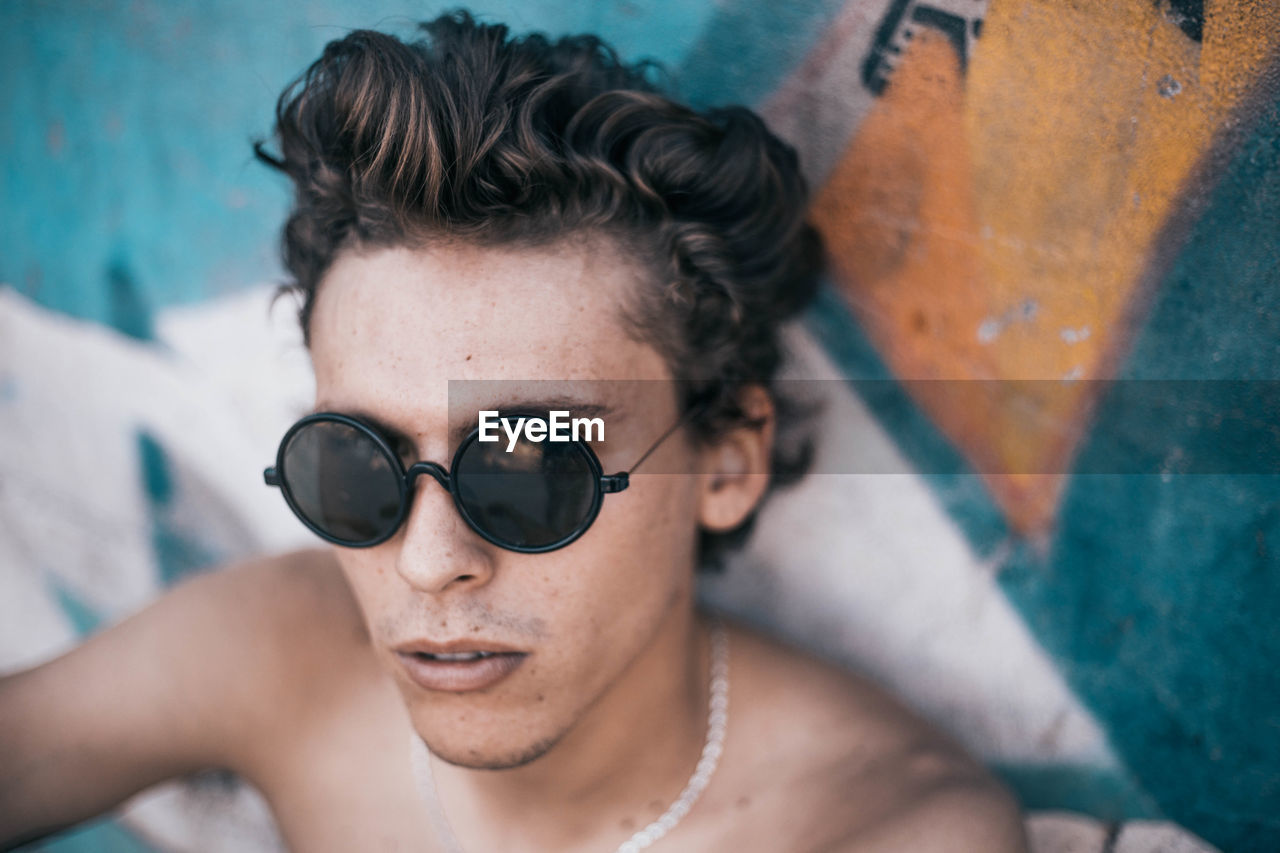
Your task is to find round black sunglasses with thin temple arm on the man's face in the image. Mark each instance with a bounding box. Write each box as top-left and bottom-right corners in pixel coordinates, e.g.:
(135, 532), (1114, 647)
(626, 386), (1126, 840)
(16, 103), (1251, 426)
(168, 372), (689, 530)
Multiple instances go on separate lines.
(262, 406), (700, 553)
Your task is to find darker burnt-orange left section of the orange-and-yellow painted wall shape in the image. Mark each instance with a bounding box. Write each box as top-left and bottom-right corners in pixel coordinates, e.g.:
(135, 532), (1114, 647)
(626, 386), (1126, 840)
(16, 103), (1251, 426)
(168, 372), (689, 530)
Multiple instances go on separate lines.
(813, 29), (1057, 529)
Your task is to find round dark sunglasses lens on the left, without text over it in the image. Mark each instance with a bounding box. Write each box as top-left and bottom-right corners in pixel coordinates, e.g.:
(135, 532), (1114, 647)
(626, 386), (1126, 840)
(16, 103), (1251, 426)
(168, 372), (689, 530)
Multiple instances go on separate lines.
(282, 420), (401, 543)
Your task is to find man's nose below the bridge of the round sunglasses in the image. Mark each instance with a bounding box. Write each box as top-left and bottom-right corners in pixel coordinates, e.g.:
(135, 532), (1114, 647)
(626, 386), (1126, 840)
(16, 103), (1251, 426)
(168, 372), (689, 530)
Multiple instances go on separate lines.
(393, 466), (494, 594)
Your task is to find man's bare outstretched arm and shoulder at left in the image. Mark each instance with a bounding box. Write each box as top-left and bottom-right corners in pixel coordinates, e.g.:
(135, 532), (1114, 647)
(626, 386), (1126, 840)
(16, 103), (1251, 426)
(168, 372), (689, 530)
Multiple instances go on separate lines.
(0, 555), (350, 848)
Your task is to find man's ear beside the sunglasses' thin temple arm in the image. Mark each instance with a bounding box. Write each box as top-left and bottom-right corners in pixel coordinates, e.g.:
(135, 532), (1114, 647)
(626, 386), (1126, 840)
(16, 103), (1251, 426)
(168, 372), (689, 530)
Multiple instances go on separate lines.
(698, 386), (776, 533)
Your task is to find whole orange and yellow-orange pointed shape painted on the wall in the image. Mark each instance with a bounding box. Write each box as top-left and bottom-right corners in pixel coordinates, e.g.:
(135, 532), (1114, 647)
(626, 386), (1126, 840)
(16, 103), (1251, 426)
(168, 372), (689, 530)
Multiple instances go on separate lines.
(814, 0), (1280, 533)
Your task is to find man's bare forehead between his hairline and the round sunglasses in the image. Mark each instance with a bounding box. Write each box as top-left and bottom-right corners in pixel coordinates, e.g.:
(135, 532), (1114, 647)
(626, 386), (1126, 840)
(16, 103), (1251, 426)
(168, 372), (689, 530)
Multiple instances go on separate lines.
(311, 241), (669, 438)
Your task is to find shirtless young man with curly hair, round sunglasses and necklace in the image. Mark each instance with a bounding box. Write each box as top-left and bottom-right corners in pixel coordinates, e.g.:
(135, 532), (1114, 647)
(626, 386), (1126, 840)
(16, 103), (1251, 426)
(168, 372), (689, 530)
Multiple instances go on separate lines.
(0, 14), (1025, 853)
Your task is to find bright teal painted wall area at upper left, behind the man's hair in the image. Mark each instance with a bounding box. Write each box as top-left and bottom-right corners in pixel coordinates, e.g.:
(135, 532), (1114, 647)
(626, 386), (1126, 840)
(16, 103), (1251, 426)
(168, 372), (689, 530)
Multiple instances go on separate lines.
(0, 0), (732, 327)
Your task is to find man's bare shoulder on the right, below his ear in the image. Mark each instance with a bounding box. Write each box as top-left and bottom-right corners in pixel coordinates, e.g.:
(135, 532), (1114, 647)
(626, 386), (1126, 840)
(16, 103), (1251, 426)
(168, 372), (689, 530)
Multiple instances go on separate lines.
(726, 617), (1027, 853)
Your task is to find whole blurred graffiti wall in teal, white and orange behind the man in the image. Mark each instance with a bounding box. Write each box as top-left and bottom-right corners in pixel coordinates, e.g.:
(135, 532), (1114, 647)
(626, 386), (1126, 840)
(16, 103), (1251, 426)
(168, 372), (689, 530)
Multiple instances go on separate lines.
(0, 0), (1280, 852)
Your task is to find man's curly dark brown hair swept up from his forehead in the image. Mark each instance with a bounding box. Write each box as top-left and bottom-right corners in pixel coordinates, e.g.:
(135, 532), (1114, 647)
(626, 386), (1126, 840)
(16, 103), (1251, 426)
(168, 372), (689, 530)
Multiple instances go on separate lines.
(253, 10), (822, 567)
